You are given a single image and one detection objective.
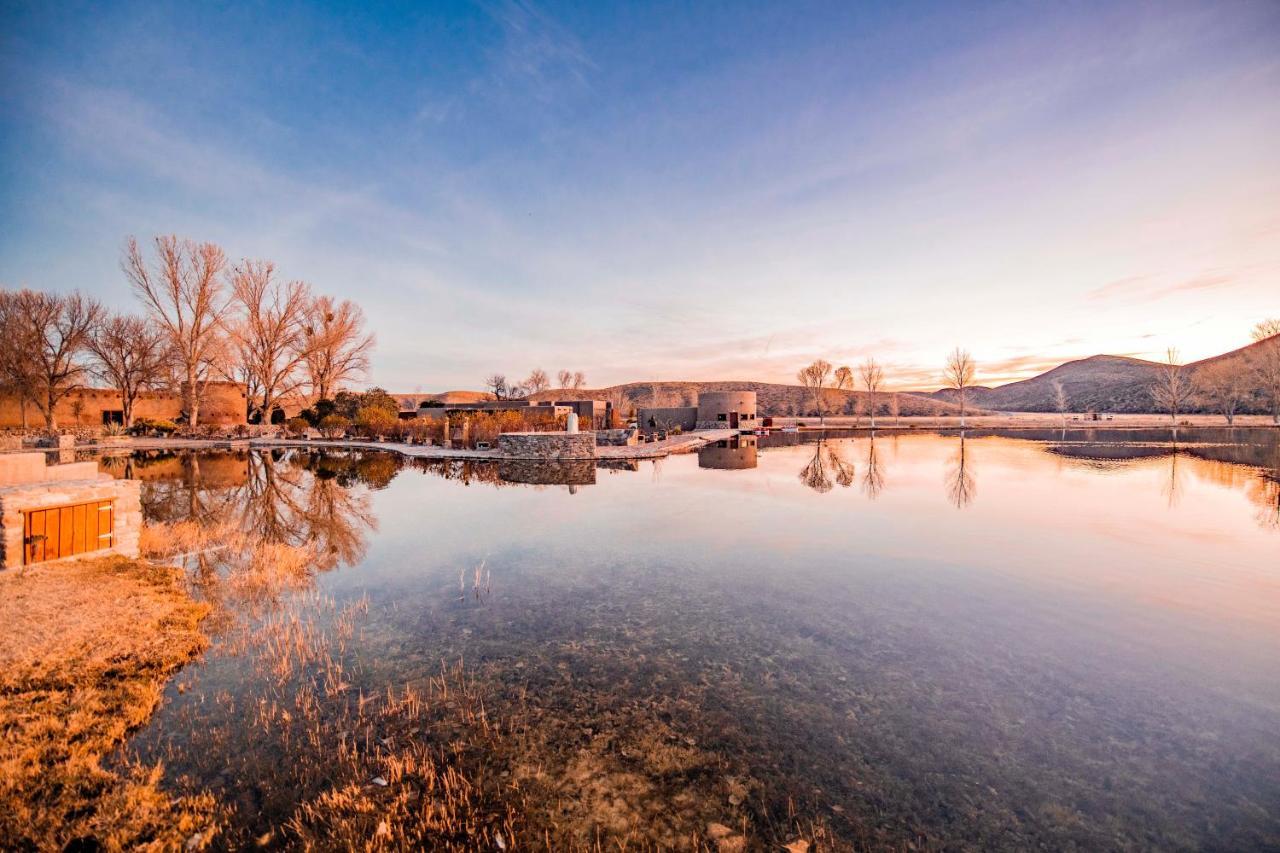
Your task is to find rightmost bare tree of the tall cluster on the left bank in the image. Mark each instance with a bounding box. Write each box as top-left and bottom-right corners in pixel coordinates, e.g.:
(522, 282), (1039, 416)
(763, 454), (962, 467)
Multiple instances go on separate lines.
(305, 296), (374, 401)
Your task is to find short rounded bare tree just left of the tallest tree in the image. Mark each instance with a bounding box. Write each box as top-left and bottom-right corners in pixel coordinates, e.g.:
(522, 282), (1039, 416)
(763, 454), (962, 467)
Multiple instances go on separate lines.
(86, 314), (170, 427)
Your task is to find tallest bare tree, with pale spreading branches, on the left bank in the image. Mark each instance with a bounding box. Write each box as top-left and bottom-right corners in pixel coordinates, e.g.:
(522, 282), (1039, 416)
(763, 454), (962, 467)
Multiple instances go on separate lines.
(122, 236), (228, 427)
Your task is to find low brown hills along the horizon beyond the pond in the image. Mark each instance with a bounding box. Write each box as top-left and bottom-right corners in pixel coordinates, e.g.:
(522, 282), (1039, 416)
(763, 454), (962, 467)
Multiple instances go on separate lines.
(413, 336), (1280, 416)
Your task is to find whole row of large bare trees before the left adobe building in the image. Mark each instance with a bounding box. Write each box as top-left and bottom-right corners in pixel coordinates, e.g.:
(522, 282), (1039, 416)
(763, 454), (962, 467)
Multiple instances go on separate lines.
(0, 236), (374, 429)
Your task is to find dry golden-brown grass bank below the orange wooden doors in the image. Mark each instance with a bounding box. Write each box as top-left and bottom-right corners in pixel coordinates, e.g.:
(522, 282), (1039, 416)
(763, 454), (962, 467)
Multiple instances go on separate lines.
(0, 557), (216, 849)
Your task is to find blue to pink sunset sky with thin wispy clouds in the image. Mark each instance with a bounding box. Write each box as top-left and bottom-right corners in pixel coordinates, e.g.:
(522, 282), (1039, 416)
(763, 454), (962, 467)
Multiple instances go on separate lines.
(0, 0), (1280, 392)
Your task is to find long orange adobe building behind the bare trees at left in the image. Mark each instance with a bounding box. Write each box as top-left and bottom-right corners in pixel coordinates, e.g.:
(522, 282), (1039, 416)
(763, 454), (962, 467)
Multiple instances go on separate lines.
(0, 382), (248, 429)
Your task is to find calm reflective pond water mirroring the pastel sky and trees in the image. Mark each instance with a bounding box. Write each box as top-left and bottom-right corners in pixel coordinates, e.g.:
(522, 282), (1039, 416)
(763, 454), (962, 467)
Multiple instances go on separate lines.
(102, 430), (1280, 849)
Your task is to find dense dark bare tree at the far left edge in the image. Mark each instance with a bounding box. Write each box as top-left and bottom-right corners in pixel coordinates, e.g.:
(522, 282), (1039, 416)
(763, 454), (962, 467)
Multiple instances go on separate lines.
(0, 289), (102, 430)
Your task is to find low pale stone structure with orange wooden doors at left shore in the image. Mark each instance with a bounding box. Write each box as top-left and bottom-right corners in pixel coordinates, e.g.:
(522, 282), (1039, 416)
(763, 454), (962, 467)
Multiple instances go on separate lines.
(0, 453), (142, 569)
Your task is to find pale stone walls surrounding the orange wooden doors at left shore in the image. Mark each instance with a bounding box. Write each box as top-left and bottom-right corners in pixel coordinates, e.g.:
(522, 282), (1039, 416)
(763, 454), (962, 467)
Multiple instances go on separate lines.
(0, 453), (142, 569)
